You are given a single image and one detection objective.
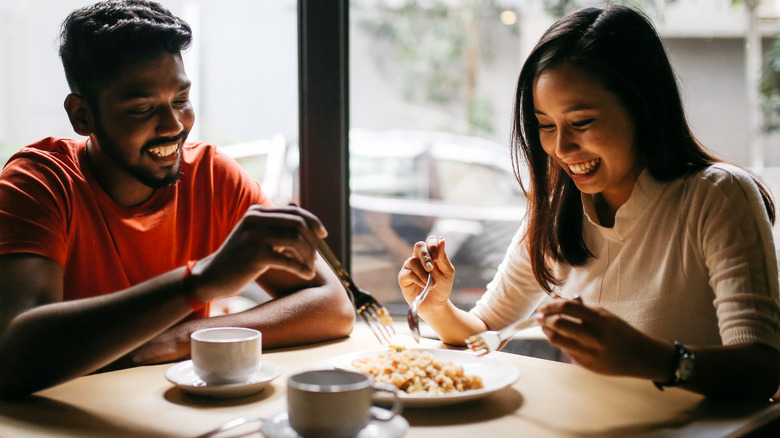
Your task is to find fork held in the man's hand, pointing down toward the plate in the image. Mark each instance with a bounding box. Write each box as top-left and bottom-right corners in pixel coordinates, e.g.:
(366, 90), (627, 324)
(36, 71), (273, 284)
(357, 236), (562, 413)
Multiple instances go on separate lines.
(317, 239), (395, 345)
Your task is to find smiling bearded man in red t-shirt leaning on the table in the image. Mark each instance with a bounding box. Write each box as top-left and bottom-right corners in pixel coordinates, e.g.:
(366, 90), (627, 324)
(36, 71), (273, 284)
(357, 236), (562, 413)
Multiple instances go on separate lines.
(0, 0), (355, 398)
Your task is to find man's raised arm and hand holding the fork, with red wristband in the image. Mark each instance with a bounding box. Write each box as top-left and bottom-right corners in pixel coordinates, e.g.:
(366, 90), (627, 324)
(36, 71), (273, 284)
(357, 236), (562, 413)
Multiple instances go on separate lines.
(0, 206), (354, 398)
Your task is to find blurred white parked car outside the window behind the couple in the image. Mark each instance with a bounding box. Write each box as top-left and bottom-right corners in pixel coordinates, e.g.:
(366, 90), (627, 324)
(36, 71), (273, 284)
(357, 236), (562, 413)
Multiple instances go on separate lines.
(220, 129), (526, 314)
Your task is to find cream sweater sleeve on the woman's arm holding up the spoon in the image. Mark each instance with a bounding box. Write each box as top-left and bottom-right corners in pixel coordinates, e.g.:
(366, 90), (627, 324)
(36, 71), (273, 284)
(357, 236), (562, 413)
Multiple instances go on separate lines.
(470, 227), (547, 330)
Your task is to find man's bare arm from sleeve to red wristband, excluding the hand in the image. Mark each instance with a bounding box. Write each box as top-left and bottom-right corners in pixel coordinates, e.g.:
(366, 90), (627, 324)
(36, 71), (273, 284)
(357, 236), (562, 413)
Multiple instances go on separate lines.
(0, 254), (198, 398)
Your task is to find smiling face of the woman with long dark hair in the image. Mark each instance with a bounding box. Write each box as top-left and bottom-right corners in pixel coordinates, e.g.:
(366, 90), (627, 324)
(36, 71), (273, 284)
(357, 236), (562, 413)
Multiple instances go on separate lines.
(533, 64), (644, 212)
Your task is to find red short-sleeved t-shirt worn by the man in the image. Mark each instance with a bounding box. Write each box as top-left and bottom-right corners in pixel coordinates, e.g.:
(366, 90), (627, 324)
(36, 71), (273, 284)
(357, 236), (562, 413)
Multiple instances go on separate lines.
(0, 138), (271, 314)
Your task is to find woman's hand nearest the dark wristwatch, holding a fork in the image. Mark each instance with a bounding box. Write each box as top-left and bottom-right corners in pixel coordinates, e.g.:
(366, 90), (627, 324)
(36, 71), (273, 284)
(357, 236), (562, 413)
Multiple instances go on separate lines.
(539, 299), (673, 381)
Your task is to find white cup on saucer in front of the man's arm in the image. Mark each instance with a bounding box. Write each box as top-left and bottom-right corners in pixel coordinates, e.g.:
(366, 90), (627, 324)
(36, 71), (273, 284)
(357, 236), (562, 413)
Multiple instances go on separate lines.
(190, 327), (263, 385)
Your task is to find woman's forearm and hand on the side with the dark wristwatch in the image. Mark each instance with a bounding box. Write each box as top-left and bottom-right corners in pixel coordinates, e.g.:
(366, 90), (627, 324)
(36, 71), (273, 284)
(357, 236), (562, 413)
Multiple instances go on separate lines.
(539, 300), (780, 400)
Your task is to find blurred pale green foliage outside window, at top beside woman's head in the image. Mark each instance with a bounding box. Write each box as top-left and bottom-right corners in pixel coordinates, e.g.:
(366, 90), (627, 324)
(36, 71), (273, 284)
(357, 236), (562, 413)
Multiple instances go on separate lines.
(358, 0), (675, 136)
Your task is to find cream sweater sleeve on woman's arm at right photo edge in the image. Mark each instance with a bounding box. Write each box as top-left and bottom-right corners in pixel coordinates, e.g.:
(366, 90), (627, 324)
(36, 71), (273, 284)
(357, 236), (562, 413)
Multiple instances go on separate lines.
(688, 165), (780, 350)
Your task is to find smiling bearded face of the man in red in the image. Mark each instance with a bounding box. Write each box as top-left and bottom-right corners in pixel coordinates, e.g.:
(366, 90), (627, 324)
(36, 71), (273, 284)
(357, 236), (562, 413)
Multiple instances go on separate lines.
(90, 53), (195, 188)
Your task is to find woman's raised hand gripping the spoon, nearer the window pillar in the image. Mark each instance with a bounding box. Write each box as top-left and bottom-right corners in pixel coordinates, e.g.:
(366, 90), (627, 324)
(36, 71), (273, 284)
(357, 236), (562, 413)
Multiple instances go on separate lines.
(398, 236), (455, 315)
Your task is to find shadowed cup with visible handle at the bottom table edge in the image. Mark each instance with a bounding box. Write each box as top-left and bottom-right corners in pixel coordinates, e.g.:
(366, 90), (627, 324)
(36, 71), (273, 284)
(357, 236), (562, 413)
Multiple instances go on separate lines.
(287, 369), (401, 438)
